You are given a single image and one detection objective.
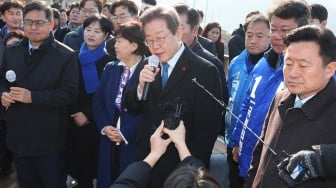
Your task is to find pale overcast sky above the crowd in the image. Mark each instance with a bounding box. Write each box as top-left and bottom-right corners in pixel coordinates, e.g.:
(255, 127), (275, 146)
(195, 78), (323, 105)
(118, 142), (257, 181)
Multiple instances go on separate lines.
(137, 0), (336, 33)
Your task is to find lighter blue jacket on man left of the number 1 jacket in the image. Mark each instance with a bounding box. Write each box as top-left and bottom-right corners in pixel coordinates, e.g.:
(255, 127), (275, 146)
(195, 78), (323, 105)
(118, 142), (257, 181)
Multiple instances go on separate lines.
(225, 49), (253, 148)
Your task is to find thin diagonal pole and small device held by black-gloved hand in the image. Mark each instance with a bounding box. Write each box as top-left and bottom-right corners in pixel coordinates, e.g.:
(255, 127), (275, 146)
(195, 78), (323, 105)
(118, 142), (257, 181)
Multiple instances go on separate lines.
(191, 78), (305, 186)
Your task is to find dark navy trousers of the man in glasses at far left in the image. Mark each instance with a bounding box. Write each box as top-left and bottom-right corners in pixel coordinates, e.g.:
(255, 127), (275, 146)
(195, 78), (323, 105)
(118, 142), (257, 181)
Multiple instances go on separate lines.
(13, 153), (66, 188)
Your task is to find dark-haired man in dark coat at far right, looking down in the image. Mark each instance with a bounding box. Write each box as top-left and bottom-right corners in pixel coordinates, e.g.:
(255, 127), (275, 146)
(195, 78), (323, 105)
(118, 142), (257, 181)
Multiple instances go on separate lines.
(245, 26), (336, 188)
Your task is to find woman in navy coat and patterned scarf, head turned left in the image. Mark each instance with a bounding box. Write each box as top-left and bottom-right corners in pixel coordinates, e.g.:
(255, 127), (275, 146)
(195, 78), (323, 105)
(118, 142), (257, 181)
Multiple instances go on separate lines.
(93, 22), (147, 188)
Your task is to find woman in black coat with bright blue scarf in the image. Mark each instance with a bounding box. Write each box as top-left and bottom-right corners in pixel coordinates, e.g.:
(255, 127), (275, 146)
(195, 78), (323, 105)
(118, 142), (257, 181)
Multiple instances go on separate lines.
(67, 16), (113, 188)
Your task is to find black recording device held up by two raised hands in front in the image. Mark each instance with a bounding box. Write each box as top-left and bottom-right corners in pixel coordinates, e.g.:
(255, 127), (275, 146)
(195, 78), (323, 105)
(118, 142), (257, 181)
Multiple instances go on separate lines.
(163, 97), (186, 130)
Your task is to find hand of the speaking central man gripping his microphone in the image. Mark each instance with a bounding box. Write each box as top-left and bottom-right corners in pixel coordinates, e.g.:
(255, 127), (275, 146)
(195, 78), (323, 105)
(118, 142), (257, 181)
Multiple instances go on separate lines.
(138, 65), (160, 93)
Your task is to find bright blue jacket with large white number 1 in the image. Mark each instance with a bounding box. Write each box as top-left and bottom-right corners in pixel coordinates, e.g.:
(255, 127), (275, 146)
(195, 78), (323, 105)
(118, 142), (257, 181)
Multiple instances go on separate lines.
(231, 49), (284, 177)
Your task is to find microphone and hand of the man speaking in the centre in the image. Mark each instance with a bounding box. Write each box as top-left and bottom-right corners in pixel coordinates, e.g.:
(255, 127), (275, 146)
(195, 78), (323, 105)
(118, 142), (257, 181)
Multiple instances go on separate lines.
(139, 55), (160, 101)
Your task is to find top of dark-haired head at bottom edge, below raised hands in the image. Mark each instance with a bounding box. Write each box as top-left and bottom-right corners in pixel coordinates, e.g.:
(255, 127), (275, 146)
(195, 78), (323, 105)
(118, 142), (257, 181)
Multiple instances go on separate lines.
(164, 165), (220, 188)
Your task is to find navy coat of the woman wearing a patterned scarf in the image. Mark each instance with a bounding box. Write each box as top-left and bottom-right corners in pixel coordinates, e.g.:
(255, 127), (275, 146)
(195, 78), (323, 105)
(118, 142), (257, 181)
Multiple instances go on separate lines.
(93, 58), (144, 188)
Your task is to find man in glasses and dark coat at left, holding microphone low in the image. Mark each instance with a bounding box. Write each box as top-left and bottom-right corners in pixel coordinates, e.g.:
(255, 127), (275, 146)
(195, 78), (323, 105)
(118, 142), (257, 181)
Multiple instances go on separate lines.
(0, 1), (78, 188)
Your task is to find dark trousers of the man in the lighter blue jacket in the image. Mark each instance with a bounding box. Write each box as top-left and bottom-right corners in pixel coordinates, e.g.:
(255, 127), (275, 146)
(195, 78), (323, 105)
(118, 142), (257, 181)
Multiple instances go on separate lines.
(226, 146), (244, 188)
